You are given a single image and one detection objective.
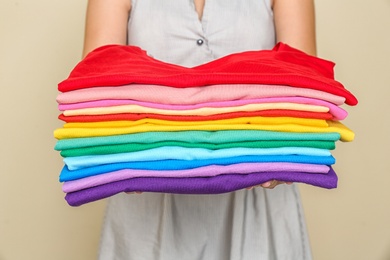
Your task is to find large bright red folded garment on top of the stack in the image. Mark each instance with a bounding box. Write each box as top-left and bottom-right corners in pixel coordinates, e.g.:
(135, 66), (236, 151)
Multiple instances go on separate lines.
(58, 43), (357, 105)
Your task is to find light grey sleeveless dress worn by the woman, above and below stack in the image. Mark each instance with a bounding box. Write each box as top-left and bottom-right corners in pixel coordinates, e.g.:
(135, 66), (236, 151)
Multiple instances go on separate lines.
(99, 0), (311, 260)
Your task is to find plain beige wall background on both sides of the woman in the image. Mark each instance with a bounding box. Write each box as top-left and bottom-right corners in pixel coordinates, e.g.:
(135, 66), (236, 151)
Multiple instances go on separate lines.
(0, 0), (390, 260)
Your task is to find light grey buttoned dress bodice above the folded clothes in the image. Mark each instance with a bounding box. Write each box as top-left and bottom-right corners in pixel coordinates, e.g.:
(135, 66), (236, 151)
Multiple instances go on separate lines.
(128, 0), (275, 67)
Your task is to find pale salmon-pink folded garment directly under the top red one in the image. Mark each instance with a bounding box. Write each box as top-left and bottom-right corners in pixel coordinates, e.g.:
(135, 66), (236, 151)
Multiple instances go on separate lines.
(57, 84), (345, 105)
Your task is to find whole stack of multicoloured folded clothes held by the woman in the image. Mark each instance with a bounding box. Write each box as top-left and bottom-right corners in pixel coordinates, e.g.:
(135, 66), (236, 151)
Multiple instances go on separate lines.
(54, 43), (357, 206)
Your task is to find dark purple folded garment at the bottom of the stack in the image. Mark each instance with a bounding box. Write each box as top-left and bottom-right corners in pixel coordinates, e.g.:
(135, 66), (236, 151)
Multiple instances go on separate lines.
(65, 168), (337, 206)
